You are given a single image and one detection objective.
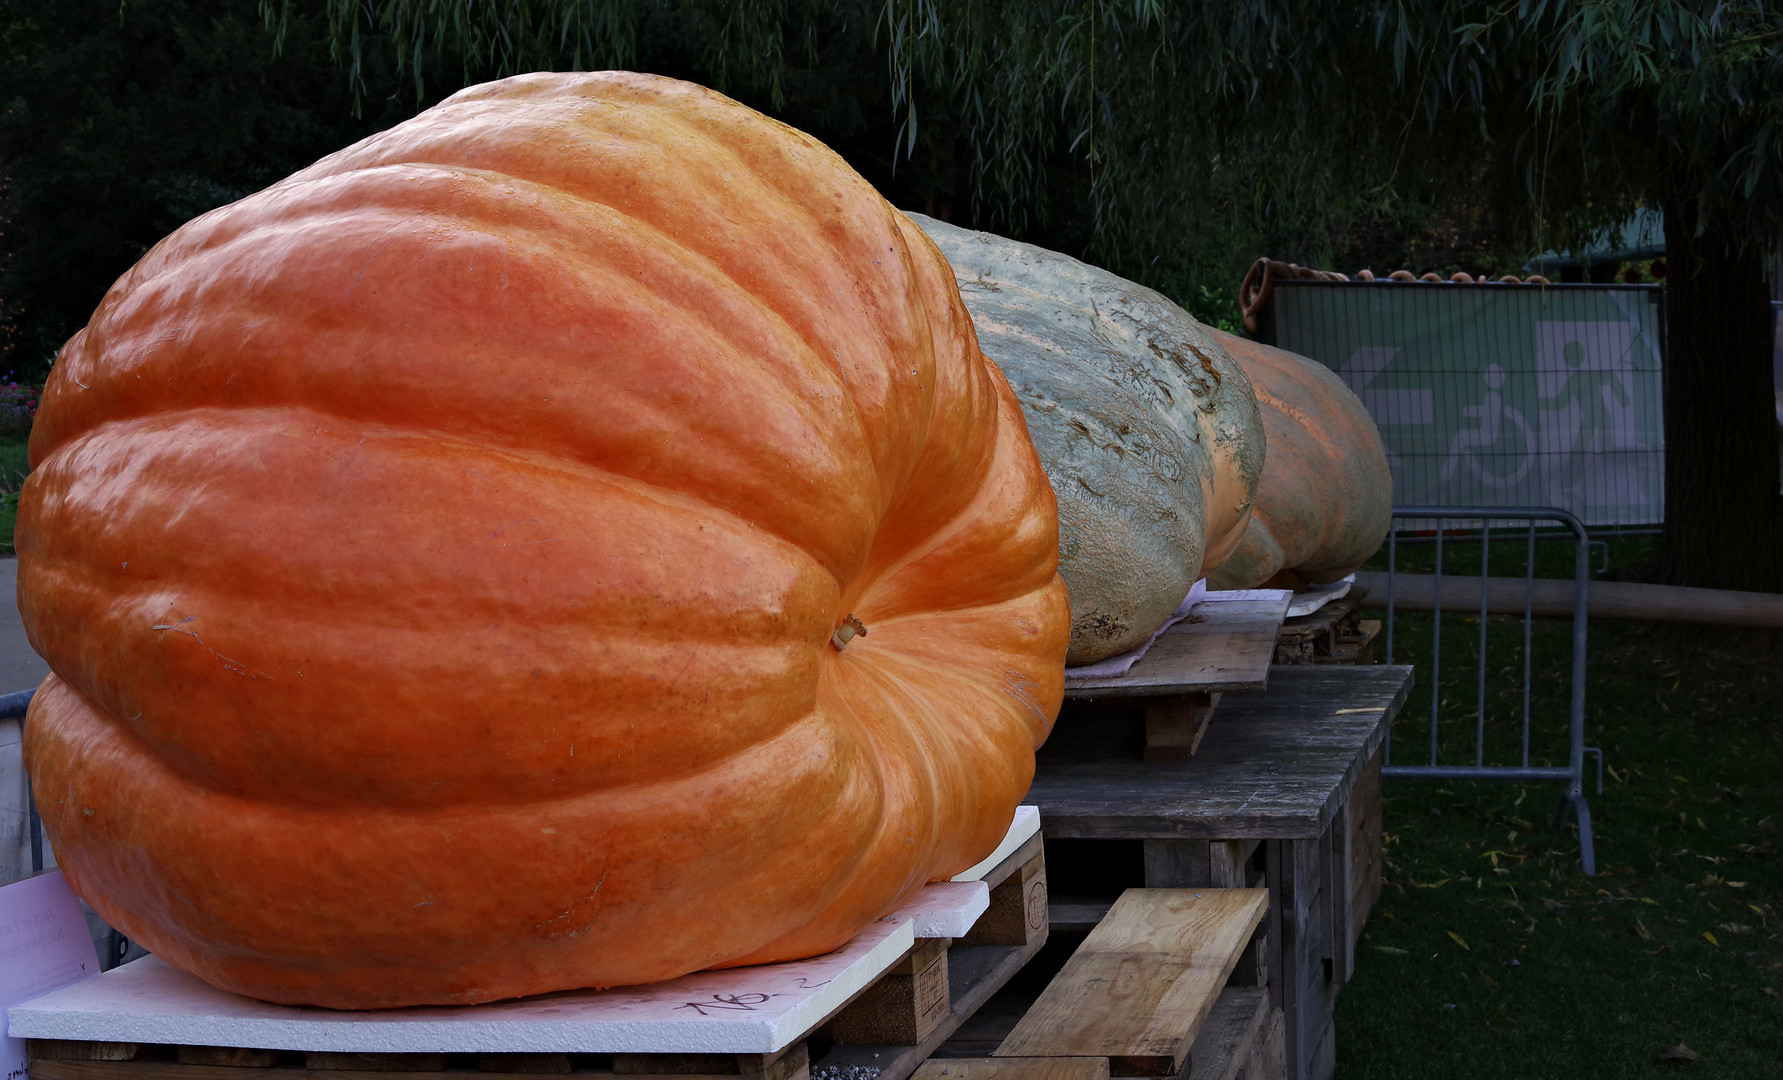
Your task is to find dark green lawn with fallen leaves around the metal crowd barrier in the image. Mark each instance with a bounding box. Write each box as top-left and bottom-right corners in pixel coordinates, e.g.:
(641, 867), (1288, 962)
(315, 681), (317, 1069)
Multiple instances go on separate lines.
(1337, 540), (1783, 1080)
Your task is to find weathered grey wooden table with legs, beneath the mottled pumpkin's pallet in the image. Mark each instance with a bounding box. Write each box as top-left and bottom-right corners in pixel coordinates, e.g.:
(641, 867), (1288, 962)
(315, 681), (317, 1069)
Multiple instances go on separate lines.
(1027, 665), (1412, 1080)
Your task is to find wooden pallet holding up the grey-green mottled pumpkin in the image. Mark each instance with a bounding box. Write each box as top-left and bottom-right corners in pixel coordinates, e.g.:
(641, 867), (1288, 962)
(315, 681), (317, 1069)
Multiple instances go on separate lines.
(1059, 590), (1293, 761)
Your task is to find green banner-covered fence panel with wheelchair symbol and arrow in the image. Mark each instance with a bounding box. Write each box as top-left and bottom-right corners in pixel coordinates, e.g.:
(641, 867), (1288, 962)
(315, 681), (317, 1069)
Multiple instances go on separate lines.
(1262, 280), (1665, 528)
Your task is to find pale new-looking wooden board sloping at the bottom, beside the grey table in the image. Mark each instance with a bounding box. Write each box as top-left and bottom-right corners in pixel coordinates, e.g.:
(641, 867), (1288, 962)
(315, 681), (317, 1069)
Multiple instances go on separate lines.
(995, 889), (1268, 1076)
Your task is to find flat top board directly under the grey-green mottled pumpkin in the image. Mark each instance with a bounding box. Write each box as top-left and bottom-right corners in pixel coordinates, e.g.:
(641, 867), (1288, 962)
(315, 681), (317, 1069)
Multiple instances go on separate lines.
(1064, 590), (1293, 699)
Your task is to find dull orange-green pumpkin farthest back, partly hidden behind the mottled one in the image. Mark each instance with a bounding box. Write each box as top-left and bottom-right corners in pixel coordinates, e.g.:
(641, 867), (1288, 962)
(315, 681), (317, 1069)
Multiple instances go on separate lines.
(1207, 328), (1393, 590)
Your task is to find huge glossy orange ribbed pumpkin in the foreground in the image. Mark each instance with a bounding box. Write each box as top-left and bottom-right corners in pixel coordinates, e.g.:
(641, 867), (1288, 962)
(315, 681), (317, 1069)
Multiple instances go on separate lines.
(18, 73), (1068, 1009)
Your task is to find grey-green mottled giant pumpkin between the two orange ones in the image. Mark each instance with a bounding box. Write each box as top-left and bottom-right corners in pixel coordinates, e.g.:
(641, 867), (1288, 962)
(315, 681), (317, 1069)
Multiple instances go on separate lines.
(909, 214), (1264, 665)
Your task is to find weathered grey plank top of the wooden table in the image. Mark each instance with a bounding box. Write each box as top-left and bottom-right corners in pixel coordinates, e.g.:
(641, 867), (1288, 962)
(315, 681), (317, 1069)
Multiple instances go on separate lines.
(1027, 665), (1412, 839)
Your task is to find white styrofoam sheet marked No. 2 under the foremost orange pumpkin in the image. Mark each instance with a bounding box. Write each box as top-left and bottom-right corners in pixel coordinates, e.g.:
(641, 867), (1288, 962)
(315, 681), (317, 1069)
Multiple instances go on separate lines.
(9, 918), (916, 1053)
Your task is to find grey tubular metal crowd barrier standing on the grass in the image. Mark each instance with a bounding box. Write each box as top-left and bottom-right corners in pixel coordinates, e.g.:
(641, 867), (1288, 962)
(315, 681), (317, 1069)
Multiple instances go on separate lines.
(1382, 506), (1603, 875)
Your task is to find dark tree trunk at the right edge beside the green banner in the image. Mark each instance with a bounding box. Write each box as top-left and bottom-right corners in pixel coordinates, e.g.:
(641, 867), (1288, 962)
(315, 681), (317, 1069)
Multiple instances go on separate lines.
(1660, 198), (1783, 592)
